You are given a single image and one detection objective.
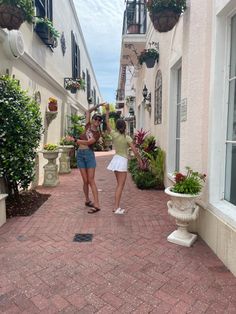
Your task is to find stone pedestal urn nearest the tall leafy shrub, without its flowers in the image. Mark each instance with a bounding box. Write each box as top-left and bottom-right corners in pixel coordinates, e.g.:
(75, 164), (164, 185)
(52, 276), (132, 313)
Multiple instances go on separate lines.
(42, 150), (59, 186)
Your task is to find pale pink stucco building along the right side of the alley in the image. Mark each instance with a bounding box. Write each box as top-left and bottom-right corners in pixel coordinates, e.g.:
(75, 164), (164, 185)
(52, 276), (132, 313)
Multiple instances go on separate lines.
(118, 0), (236, 275)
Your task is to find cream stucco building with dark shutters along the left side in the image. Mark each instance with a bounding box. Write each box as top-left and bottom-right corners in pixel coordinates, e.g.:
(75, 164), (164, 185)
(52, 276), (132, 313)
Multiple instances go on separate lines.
(0, 0), (102, 185)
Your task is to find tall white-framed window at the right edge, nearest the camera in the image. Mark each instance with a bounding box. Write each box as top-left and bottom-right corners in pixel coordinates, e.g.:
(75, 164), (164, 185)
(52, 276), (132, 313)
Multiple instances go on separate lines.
(225, 15), (236, 205)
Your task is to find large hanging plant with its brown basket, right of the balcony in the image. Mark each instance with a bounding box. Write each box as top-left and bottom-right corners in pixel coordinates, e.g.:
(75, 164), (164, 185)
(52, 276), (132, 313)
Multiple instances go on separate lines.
(146, 0), (186, 32)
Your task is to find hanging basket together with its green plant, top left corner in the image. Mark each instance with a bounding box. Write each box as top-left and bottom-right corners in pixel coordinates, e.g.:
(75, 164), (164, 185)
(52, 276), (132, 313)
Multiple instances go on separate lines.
(0, 0), (34, 30)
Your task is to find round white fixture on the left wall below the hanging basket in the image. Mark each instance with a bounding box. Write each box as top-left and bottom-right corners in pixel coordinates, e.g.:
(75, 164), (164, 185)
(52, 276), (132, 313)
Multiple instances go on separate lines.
(3, 30), (25, 59)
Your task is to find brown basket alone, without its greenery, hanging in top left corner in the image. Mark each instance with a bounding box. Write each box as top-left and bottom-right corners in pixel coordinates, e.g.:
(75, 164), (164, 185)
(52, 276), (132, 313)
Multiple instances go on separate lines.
(0, 4), (25, 30)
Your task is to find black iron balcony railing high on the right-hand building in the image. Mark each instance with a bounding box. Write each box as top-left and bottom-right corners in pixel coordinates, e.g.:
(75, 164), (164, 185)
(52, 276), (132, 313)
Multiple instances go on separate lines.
(123, 0), (147, 35)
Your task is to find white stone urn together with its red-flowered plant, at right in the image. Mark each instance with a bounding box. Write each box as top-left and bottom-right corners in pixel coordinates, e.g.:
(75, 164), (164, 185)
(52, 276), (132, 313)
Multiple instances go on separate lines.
(165, 167), (206, 247)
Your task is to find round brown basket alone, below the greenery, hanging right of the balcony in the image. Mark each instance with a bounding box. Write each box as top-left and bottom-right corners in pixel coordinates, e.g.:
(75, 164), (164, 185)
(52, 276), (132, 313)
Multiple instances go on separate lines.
(149, 9), (180, 33)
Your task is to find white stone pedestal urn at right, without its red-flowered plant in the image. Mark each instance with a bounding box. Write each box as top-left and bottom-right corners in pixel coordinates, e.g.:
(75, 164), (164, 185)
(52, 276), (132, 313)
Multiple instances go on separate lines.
(165, 187), (199, 247)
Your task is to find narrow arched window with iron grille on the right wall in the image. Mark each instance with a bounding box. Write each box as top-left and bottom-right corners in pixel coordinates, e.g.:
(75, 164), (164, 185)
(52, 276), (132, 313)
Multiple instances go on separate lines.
(154, 70), (162, 124)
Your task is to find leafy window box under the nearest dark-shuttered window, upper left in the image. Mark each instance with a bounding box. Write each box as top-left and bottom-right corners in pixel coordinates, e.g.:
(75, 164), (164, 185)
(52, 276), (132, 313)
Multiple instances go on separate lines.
(34, 17), (60, 48)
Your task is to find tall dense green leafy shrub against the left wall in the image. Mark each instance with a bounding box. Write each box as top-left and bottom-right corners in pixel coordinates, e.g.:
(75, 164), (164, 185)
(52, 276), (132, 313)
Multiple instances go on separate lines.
(0, 76), (42, 196)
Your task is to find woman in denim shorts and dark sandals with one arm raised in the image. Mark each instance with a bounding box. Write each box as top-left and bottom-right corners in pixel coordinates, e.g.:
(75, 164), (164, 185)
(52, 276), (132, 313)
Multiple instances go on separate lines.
(76, 104), (103, 214)
